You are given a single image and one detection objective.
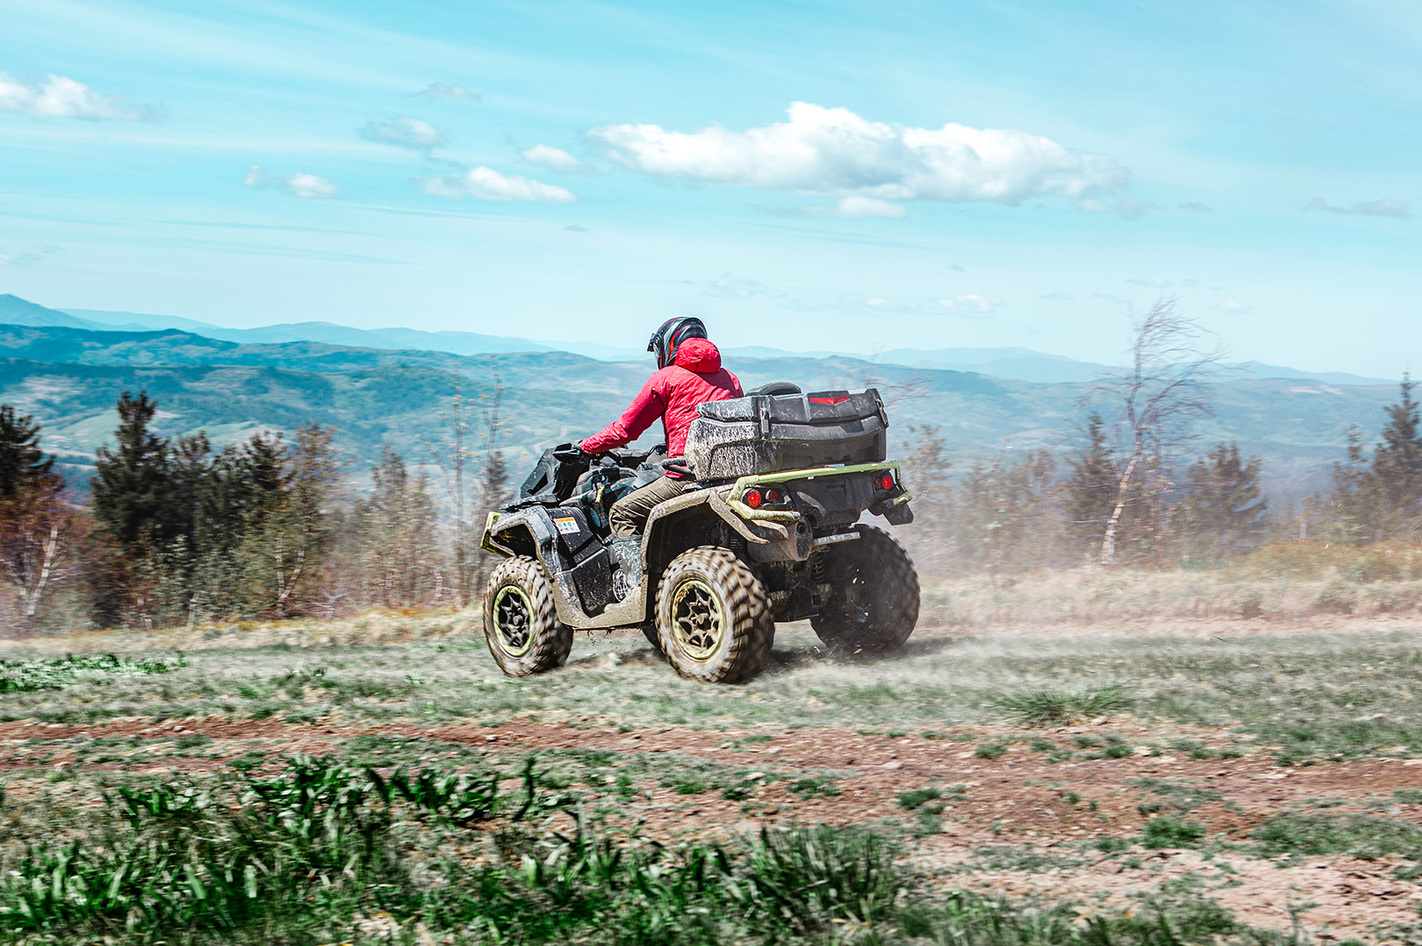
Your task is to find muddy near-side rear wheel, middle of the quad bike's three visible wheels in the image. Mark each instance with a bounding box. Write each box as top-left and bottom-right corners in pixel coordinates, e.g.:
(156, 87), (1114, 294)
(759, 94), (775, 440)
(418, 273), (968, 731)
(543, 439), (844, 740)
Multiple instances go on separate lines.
(657, 545), (775, 683)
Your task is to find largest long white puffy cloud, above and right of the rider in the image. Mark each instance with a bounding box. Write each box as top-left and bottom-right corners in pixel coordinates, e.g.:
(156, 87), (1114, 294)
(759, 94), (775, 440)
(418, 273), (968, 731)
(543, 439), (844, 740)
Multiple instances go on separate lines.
(589, 102), (1135, 208)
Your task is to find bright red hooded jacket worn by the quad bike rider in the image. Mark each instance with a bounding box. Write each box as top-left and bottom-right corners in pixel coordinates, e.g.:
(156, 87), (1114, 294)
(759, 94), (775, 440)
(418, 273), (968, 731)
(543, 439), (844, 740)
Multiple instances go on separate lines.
(580, 339), (741, 457)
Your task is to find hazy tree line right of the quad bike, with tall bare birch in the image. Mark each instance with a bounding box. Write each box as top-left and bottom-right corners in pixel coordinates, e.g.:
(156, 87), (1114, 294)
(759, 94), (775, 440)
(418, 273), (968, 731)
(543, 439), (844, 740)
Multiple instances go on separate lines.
(903, 300), (1422, 576)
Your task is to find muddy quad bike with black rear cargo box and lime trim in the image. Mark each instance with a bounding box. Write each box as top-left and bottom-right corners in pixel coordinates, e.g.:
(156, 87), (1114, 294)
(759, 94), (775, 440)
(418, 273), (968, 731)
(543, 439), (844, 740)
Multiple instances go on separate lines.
(482, 384), (919, 683)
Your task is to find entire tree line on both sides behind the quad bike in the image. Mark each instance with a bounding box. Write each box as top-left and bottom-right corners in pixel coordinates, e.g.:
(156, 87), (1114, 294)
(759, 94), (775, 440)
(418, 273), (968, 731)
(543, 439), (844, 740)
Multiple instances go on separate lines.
(0, 302), (1422, 633)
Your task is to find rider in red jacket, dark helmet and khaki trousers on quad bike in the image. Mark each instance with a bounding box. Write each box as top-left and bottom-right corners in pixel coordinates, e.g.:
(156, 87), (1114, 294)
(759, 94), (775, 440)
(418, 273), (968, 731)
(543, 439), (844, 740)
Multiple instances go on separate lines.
(579, 316), (741, 543)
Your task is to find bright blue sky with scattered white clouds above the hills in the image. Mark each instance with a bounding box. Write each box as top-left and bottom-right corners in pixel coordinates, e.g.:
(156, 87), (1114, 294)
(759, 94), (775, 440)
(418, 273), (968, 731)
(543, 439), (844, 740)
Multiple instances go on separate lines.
(0, 0), (1422, 377)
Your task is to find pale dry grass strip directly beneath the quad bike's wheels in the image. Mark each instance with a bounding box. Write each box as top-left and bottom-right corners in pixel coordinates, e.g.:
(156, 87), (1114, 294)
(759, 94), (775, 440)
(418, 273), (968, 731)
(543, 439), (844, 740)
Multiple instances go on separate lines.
(0, 625), (1422, 764)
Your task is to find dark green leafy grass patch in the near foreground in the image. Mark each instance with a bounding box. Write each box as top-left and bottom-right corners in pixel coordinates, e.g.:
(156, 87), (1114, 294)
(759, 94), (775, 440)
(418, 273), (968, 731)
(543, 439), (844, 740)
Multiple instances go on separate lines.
(0, 757), (1288, 946)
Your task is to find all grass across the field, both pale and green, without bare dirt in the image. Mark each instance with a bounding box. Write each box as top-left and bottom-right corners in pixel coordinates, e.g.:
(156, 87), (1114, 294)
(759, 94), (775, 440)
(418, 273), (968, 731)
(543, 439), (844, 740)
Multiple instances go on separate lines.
(0, 606), (1422, 946)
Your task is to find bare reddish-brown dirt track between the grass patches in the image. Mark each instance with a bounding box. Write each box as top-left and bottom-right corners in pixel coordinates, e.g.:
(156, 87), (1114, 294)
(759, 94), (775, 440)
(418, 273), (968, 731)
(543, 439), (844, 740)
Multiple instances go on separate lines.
(0, 705), (1422, 942)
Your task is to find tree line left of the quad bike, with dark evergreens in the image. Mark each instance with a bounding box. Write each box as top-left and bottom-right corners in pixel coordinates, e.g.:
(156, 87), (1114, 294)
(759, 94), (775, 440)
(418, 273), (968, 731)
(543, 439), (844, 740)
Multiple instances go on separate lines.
(0, 387), (508, 634)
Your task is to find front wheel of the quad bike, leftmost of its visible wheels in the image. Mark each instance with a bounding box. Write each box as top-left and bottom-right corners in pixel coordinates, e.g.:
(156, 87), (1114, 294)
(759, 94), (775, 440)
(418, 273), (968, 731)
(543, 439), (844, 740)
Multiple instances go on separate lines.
(483, 555), (573, 677)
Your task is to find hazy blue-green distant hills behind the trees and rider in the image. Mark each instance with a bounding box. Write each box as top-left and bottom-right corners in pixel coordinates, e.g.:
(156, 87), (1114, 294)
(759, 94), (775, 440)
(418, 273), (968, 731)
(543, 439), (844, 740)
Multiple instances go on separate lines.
(0, 317), (1396, 496)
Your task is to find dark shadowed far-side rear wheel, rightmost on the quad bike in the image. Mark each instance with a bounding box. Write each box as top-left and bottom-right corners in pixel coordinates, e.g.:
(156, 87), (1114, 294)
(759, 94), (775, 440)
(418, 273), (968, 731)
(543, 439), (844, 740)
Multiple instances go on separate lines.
(809, 525), (919, 650)
